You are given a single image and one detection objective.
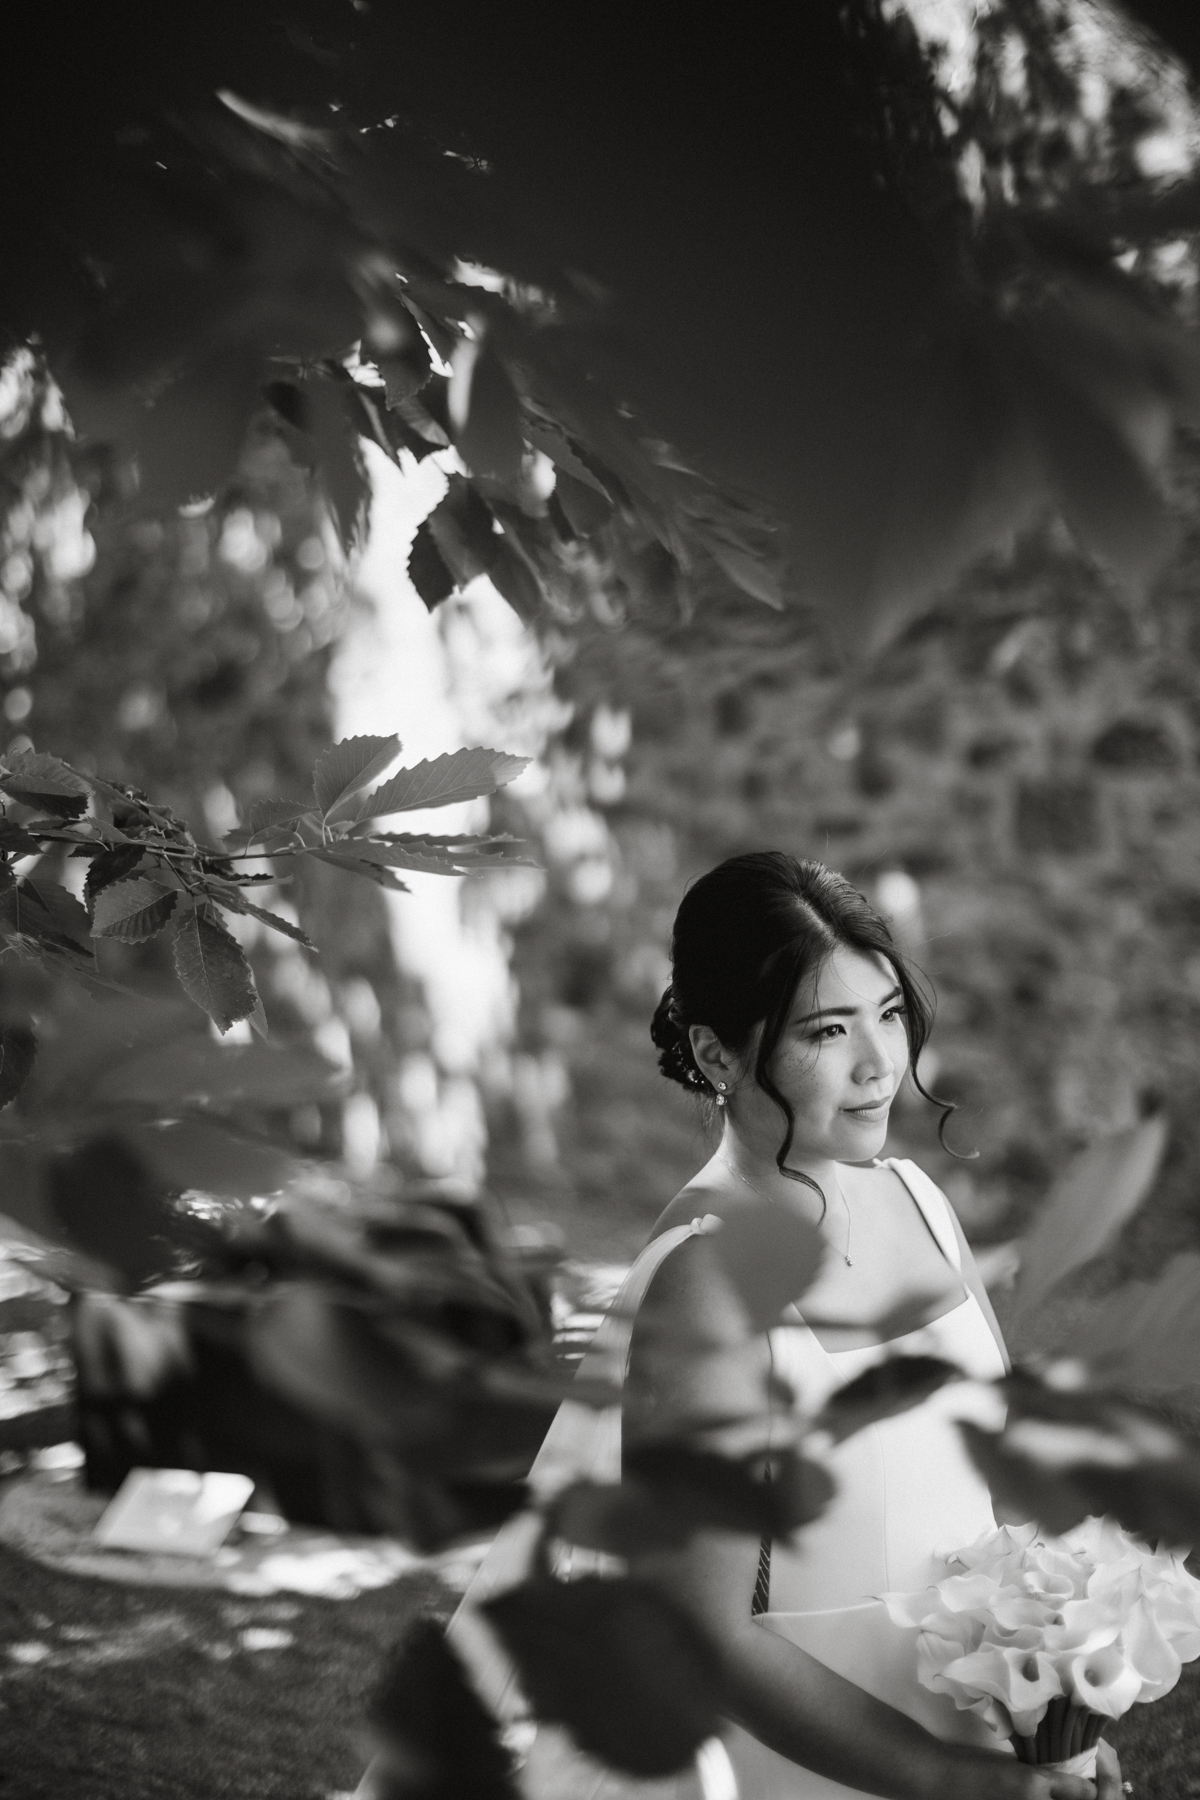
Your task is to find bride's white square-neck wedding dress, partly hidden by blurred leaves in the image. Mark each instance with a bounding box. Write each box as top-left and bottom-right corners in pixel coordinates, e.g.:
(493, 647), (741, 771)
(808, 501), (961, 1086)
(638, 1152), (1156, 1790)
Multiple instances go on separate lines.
(399, 1159), (1004, 1800)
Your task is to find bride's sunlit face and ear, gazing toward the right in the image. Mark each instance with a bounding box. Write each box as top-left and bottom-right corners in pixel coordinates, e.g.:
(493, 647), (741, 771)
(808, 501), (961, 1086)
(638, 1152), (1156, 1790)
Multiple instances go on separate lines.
(738, 949), (909, 1163)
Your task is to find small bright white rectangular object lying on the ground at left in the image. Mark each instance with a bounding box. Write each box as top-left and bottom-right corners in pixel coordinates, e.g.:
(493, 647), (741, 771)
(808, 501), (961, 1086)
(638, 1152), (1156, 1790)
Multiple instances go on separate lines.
(94, 1469), (254, 1557)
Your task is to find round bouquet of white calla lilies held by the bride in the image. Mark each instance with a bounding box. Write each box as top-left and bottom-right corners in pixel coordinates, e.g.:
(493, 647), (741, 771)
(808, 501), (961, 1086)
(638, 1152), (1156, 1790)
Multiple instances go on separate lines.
(882, 1519), (1200, 1775)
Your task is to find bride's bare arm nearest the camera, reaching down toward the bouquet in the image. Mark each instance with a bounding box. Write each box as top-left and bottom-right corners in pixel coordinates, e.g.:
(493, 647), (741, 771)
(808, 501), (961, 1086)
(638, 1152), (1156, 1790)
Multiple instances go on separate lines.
(624, 1238), (1096, 1800)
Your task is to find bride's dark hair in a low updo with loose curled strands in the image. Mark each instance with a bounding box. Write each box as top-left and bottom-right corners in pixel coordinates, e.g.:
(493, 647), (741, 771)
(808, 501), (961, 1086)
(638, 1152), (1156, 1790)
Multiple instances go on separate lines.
(649, 850), (955, 1199)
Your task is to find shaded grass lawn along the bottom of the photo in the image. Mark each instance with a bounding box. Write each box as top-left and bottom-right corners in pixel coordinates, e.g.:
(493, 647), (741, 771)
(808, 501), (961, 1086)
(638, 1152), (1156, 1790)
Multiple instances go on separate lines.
(0, 1548), (1200, 1800)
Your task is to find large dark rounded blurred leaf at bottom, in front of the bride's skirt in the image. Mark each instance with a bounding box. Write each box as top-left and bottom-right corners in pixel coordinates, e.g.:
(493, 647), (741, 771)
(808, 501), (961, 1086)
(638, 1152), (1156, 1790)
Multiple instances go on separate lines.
(484, 1575), (721, 1777)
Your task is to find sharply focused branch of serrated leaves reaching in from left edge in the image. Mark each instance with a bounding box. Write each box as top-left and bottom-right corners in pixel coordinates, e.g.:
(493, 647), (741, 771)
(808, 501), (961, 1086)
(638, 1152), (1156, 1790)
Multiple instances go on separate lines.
(0, 736), (527, 1080)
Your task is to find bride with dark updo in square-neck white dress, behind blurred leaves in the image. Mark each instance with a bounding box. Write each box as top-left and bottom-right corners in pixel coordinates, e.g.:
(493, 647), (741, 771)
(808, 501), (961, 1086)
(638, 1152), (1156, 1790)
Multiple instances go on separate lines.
(624, 851), (1121, 1800)
